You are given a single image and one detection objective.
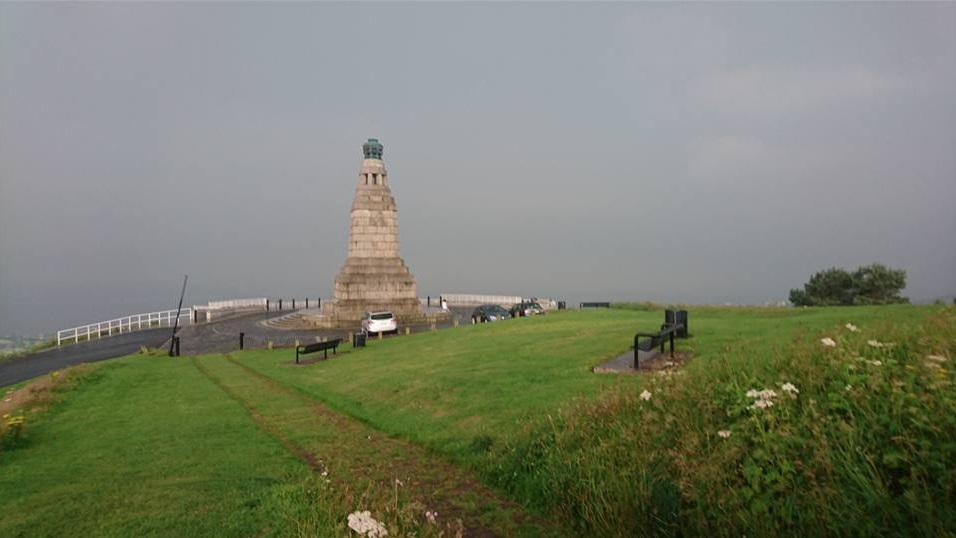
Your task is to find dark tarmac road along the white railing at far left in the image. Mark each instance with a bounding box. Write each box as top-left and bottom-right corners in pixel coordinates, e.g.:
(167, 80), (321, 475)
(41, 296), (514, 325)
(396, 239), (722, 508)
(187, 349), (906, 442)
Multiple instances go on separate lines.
(0, 327), (172, 387)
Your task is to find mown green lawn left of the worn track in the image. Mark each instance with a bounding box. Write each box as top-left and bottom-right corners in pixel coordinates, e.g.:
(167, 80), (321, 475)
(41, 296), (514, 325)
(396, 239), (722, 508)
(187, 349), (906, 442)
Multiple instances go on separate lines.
(0, 357), (318, 536)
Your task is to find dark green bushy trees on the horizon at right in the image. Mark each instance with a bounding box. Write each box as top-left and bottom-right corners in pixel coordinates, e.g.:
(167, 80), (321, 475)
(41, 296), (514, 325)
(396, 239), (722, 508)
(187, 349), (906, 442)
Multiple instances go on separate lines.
(790, 263), (909, 306)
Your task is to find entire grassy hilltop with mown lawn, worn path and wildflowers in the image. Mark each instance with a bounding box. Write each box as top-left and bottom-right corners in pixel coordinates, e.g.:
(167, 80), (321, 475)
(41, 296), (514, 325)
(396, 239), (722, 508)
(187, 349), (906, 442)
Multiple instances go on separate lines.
(0, 305), (956, 536)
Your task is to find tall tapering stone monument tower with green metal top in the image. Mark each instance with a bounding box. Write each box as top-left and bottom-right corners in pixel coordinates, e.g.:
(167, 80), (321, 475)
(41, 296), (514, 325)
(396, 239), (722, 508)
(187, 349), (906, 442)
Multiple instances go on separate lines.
(322, 138), (425, 325)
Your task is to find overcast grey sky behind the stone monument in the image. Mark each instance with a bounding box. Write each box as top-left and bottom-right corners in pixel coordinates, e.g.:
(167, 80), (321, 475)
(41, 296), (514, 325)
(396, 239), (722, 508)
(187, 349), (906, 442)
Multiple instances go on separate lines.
(0, 2), (956, 333)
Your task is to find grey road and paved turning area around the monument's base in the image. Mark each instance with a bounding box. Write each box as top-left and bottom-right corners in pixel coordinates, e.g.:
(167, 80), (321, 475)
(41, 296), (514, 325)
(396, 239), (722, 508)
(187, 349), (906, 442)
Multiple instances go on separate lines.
(0, 307), (474, 387)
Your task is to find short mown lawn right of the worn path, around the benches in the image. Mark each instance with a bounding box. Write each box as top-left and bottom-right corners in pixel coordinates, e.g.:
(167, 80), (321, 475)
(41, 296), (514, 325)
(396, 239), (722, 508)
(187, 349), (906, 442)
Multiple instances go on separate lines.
(230, 305), (929, 460)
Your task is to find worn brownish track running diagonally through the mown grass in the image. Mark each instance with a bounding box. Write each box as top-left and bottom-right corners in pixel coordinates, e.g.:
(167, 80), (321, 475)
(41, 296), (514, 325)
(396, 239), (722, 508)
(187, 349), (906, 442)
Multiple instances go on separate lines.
(193, 356), (560, 536)
